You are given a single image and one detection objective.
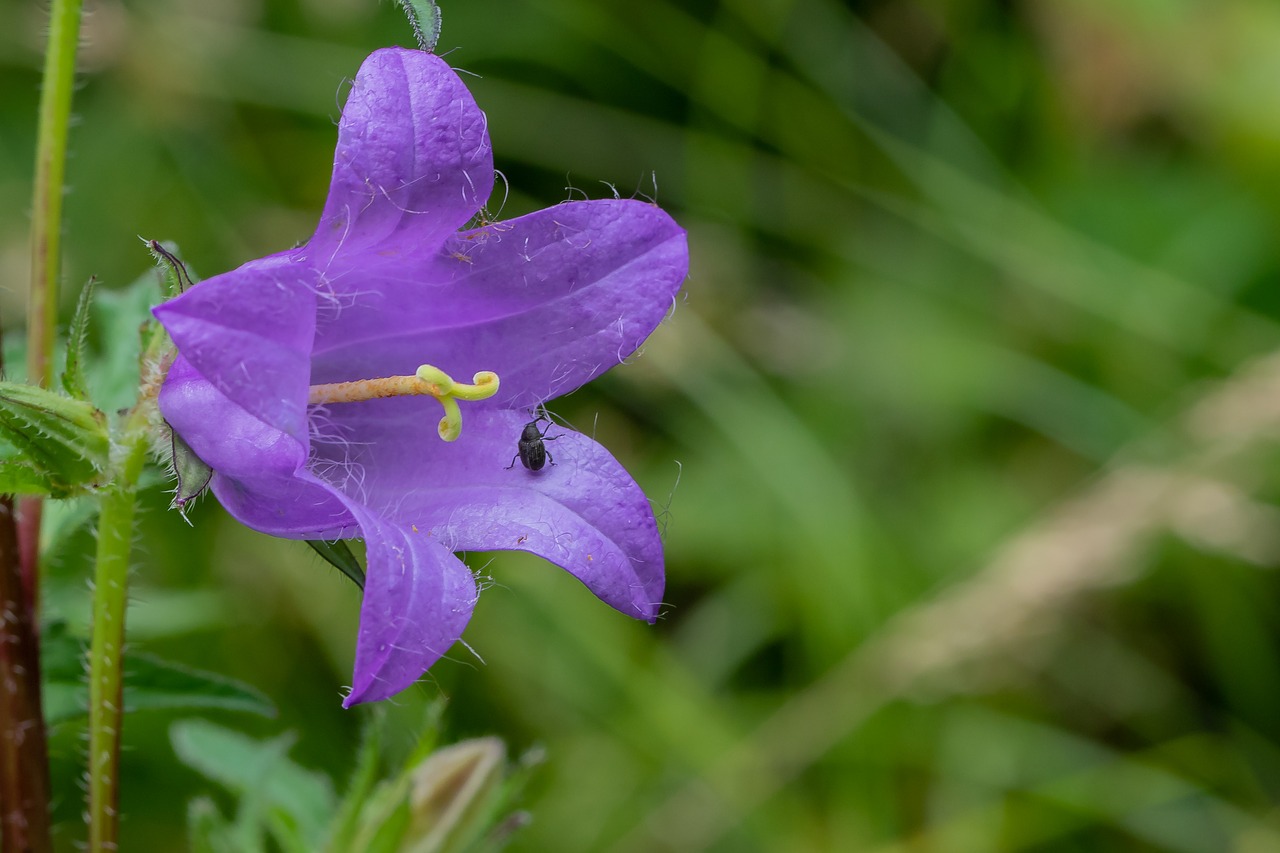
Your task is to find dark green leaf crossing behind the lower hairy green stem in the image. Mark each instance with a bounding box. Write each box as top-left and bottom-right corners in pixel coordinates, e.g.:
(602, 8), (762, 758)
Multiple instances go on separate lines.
(41, 622), (275, 725)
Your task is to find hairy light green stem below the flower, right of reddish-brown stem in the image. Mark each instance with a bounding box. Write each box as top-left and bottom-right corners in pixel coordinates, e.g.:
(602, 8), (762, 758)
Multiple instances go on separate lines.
(88, 427), (147, 853)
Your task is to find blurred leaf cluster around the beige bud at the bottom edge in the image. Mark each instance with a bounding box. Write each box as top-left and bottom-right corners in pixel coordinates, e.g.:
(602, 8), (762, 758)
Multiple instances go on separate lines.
(172, 703), (529, 853)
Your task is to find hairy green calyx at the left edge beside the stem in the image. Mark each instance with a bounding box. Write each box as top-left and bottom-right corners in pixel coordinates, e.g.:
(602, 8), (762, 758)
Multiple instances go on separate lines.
(0, 382), (110, 497)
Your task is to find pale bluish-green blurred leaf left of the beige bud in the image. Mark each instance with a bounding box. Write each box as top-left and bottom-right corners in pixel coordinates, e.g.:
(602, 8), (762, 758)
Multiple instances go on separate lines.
(169, 720), (334, 850)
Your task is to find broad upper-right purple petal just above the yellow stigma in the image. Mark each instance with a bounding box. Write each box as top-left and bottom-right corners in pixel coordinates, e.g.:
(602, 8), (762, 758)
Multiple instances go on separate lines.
(312, 200), (689, 409)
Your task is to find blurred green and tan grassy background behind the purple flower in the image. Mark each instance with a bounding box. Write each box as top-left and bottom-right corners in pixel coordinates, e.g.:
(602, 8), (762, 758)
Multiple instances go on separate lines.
(0, 0), (1280, 852)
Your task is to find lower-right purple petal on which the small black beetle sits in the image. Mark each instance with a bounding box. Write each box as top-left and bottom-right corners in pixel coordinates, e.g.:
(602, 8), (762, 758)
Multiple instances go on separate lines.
(311, 400), (663, 621)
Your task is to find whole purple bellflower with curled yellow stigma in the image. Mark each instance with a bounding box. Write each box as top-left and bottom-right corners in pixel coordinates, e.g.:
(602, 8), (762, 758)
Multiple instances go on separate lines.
(155, 49), (689, 707)
